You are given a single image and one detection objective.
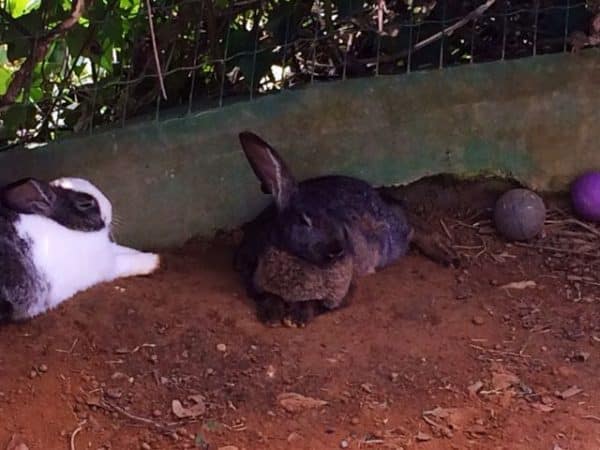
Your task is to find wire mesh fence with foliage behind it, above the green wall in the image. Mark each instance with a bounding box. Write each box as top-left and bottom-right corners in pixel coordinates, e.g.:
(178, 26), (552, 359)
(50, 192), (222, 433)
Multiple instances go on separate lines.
(0, 0), (600, 148)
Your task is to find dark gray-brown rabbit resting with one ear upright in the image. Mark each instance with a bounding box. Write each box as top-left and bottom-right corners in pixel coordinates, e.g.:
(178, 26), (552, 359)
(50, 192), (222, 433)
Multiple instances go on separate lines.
(236, 131), (413, 326)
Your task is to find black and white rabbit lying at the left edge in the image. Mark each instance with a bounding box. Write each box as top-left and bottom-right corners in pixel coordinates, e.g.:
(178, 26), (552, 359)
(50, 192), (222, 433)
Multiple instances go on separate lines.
(0, 178), (160, 320)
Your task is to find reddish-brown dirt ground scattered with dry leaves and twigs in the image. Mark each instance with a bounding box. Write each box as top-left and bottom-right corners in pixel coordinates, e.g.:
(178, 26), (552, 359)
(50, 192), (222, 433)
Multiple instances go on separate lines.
(0, 180), (600, 450)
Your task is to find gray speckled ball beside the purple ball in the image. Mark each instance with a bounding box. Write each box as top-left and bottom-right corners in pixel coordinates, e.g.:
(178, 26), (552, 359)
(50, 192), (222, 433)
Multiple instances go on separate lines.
(494, 189), (546, 241)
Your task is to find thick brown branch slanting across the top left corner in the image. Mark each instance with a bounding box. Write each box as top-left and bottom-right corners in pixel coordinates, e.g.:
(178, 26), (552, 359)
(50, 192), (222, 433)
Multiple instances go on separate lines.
(0, 0), (93, 112)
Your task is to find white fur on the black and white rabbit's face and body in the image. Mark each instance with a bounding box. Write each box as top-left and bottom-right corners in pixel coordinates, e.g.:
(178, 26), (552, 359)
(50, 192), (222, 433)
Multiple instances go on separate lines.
(15, 178), (160, 317)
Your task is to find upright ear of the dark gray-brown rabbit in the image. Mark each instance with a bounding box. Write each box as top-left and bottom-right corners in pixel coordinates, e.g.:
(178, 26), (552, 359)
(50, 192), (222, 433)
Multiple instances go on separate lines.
(240, 131), (297, 209)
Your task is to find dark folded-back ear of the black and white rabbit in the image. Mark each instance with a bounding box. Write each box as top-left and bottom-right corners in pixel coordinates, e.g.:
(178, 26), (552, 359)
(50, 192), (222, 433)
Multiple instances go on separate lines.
(0, 178), (56, 216)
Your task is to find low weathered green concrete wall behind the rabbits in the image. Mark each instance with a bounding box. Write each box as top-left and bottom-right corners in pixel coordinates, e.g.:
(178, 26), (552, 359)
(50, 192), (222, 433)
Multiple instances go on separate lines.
(0, 49), (600, 248)
